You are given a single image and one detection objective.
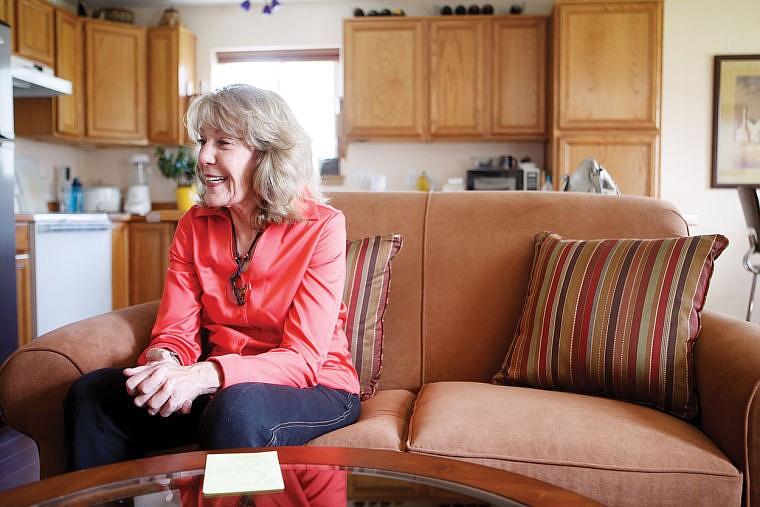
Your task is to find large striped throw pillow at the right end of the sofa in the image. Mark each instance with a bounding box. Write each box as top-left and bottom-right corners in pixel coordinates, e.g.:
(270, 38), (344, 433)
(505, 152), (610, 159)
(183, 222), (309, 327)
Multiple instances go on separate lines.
(493, 232), (728, 419)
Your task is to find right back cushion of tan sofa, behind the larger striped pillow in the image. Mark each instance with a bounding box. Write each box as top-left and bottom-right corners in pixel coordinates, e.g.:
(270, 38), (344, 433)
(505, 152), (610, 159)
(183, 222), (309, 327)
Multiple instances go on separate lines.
(422, 191), (688, 382)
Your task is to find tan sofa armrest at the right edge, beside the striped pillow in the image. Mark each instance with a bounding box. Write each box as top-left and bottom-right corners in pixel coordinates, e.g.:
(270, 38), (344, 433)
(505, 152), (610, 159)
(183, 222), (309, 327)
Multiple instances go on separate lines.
(694, 311), (760, 505)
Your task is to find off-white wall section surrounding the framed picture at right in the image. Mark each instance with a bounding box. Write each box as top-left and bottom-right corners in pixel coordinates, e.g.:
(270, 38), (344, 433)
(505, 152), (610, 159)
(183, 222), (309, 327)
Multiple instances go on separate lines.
(661, 0), (760, 321)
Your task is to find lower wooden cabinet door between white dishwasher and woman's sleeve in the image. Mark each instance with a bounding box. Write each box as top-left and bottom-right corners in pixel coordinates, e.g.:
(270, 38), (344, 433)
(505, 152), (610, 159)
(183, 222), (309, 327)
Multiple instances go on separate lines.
(129, 222), (177, 305)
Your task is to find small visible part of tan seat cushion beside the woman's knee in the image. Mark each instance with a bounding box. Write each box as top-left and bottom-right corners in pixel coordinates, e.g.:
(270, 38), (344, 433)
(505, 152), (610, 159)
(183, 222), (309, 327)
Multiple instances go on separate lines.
(308, 389), (415, 451)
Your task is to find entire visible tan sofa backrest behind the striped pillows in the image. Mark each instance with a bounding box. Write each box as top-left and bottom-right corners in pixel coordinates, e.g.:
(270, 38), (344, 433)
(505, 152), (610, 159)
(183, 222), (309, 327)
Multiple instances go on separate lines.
(330, 191), (688, 390)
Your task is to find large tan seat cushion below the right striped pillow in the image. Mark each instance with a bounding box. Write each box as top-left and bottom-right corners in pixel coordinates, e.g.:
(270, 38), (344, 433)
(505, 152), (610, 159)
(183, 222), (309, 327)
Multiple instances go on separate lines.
(407, 382), (742, 506)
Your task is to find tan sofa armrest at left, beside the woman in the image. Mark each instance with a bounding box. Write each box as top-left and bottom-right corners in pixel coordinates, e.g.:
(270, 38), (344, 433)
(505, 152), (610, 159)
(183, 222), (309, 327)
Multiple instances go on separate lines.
(0, 302), (158, 478)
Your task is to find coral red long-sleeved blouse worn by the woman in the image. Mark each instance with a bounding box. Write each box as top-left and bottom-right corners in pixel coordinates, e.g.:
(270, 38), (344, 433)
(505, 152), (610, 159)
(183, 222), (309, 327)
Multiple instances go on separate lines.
(138, 202), (359, 393)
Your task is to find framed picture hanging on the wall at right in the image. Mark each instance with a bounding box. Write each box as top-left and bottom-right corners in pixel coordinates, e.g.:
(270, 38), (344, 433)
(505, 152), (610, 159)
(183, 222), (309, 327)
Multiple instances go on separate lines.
(711, 55), (760, 188)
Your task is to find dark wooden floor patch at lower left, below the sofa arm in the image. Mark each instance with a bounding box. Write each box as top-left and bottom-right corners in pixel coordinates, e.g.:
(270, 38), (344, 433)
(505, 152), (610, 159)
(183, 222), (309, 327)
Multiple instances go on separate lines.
(0, 420), (40, 491)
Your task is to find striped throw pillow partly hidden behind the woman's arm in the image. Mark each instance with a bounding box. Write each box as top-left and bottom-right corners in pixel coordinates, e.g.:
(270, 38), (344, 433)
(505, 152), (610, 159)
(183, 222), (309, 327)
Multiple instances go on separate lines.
(343, 234), (402, 400)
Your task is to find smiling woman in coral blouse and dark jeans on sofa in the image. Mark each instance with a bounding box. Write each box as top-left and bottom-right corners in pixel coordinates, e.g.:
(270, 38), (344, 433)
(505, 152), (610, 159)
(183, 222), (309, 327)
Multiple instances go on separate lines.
(65, 84), (360, 470)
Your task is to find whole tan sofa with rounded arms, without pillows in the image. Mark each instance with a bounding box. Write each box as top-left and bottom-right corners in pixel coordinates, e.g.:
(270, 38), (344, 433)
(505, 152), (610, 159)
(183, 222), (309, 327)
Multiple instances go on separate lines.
(0, 192), (760, 506)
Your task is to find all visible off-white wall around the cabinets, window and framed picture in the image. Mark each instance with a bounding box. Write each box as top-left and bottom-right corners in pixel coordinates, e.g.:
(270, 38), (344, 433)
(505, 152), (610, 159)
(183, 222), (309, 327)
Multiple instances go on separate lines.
(17, 0), (760, 318)
